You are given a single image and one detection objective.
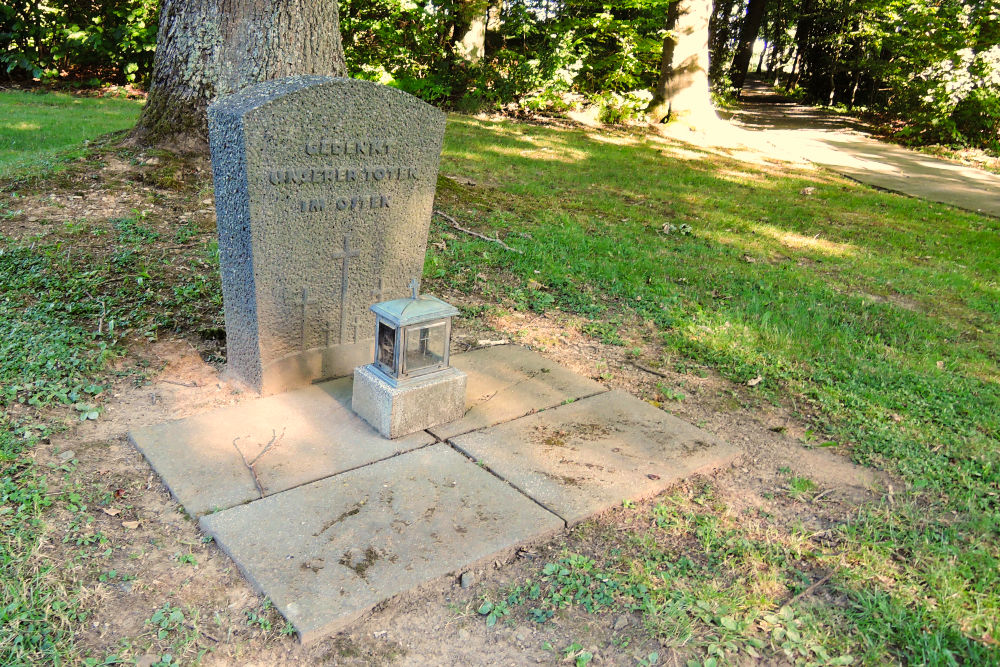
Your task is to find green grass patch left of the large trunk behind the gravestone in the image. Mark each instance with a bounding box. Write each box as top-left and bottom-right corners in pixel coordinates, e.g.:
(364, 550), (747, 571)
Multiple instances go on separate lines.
(0, 91), (142, 179)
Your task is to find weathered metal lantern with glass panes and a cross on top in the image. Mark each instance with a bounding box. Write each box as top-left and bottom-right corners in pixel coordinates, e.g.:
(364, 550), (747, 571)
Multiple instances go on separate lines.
(371, 280), (458, 386)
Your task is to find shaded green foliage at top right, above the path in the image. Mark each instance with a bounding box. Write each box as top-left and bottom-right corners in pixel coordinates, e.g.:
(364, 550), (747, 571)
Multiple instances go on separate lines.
(712, 0), (1000, 150)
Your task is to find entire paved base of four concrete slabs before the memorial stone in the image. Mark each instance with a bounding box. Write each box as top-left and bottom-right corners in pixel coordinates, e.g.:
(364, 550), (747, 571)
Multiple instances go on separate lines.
(129, 346), (739, 642)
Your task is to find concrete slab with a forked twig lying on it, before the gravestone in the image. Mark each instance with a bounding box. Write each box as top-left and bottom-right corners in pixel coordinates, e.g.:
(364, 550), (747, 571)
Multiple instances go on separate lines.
(129, 378), (434, 516)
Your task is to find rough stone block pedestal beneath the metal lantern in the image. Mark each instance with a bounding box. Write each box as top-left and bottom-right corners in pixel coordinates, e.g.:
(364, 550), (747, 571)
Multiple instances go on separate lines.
(351, 365), (466, 438)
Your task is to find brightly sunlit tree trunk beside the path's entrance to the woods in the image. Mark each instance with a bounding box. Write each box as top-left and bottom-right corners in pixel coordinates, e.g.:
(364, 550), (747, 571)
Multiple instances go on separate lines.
(646, 0), (717, 123)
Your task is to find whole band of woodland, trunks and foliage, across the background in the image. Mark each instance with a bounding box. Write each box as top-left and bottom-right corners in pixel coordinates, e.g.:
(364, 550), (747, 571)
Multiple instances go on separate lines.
(0, 0), (1000, 150)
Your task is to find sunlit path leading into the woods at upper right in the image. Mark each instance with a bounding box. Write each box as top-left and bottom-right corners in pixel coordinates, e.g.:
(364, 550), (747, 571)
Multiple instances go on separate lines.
(732, 82), (1000, 217)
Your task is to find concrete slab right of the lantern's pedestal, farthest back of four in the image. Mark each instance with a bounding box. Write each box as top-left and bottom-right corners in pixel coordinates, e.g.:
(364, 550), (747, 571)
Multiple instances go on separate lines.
(428, 345), (607, 440)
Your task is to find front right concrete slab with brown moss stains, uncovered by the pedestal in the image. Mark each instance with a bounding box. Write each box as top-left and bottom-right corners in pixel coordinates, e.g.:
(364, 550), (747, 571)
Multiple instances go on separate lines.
(450, 391), (740, 525)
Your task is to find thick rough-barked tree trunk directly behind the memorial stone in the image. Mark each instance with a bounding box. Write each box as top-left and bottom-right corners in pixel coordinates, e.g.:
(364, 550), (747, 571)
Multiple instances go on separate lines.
(131, 0), (346, 151)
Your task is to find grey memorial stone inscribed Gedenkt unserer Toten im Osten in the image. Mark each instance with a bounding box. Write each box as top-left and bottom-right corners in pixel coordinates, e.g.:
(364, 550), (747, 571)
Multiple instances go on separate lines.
(209, 76), (445, 394)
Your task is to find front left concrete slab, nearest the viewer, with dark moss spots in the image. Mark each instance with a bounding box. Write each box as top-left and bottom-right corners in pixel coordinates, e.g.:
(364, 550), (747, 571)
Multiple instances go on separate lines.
(201, 443), (563, 642)
